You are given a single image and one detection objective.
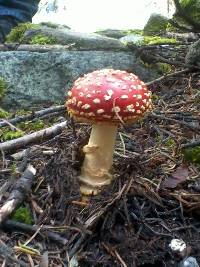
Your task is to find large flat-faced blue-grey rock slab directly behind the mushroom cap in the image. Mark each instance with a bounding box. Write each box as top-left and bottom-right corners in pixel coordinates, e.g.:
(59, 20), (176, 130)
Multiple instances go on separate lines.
(0, 51), (156, 110)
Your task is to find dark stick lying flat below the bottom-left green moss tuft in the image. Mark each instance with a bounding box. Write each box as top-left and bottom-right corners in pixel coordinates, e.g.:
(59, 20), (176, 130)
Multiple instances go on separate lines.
(2, 220), (68, 245)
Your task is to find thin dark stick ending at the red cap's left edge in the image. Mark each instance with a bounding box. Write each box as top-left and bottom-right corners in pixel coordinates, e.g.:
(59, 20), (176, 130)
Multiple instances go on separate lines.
(0, 105), (66, 127)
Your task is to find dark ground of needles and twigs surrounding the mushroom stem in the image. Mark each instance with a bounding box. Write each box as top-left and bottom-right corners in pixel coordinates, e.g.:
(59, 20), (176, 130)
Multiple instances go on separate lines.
(0, 70), (200, 267)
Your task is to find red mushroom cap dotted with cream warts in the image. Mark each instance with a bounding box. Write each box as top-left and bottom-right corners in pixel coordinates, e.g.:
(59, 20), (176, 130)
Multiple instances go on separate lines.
(66, 69), (152, 123)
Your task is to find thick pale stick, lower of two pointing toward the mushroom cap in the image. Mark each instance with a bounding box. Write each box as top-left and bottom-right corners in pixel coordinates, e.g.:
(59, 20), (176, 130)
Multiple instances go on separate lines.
(0, 121), (67, 152)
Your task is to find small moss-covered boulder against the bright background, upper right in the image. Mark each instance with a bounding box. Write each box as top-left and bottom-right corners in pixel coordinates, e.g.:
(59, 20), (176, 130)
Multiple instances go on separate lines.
(143, 14), (168, 35)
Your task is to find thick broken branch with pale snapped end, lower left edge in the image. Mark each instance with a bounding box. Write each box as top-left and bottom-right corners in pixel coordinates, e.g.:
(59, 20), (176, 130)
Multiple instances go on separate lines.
(0, 165), (36, 225)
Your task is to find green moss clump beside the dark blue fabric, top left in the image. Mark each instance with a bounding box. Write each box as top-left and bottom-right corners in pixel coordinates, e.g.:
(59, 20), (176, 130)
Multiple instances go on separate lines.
(6, 22), (39, 43)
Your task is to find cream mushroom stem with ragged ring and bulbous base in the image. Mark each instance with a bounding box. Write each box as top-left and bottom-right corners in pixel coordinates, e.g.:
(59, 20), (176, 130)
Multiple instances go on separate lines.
(79, 123), (117, 195)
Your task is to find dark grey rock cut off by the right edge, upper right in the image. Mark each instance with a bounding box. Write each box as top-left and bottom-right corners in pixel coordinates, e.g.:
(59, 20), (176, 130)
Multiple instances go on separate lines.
(185, 39), (200, 66)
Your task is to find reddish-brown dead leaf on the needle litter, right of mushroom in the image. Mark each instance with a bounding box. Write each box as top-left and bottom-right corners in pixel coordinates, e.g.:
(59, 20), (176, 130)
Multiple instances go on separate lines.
(161, 165), (189, 189)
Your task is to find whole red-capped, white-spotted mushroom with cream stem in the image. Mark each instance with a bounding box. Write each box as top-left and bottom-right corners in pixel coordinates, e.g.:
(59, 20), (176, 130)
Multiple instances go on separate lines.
(66, 69), (152, 195)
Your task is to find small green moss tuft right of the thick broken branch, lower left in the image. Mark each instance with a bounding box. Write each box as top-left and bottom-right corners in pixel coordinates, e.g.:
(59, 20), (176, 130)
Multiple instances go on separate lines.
(11, 207), (33, 224)
